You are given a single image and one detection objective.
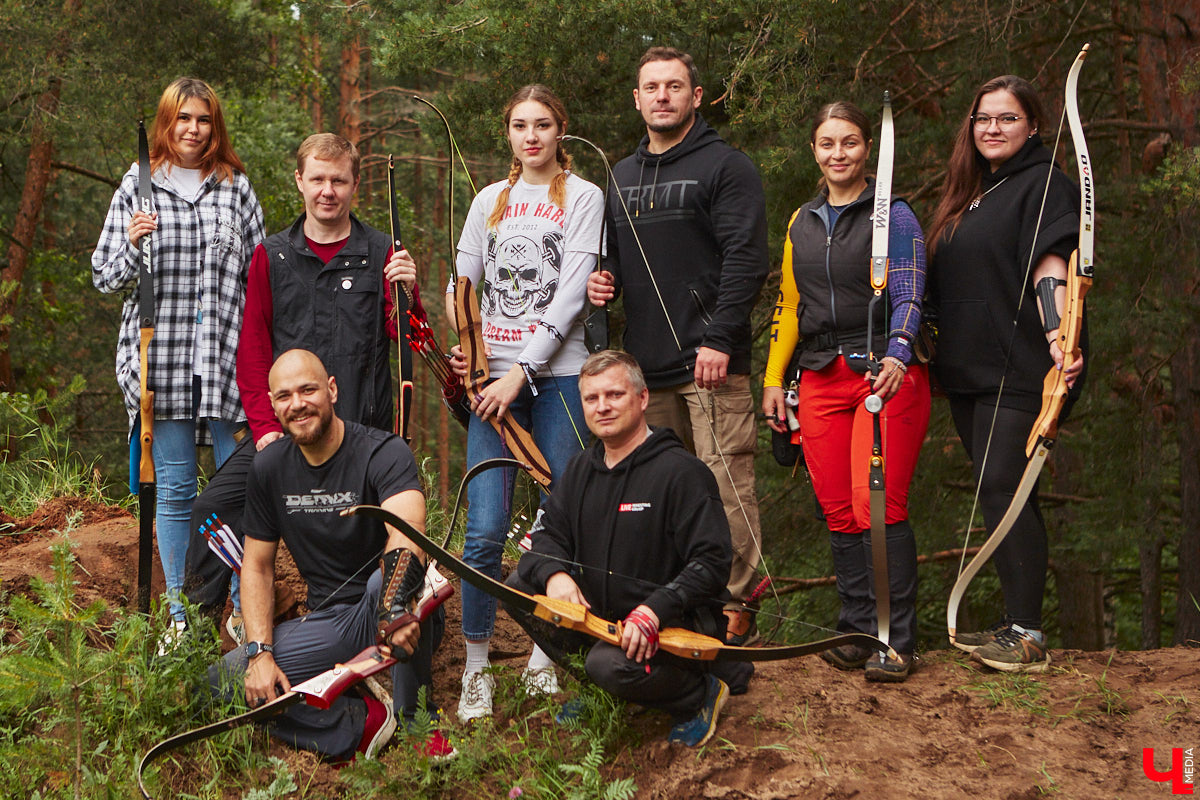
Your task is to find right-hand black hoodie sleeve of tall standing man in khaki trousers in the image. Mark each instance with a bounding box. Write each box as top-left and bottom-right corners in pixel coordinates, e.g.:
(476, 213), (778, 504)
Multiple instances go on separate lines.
(702, 149), (768, 354)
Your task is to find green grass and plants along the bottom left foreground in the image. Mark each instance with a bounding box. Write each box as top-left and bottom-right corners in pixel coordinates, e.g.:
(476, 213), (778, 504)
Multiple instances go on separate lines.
(0, 532), (636, 800)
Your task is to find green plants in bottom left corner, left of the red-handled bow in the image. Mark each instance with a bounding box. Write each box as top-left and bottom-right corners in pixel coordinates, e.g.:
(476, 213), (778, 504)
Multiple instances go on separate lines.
(0, 539), (253, 799)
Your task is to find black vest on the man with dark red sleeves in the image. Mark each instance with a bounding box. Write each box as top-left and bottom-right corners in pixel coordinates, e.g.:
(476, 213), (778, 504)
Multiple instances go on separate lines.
(263, 215), (392, 431)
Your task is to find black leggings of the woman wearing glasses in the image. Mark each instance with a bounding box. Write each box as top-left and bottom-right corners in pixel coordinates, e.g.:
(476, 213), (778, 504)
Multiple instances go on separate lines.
(950, 396), (1049, 631)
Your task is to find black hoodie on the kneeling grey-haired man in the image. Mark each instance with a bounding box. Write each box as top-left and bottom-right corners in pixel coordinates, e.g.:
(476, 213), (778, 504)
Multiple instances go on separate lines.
(517, 428), (732, 636)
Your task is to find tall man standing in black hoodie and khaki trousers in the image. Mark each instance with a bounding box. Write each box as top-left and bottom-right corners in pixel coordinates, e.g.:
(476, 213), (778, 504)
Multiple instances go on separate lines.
(588, 47), (768, 644)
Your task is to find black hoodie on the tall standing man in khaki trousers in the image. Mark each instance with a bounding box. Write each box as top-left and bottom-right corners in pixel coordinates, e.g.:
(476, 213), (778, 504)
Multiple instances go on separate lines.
(606, 114), (768, 389)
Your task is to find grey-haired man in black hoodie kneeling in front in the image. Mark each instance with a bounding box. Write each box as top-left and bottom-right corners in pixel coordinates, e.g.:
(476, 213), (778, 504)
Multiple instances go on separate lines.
(506, 350), (754, 747)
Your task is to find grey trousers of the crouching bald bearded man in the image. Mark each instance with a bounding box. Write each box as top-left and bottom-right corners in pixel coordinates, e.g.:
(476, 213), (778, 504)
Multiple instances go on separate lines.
(209, 570), (445, 759)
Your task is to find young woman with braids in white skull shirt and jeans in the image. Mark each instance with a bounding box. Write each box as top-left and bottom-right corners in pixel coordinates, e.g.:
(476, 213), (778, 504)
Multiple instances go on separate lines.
(446, 84), (604, 722)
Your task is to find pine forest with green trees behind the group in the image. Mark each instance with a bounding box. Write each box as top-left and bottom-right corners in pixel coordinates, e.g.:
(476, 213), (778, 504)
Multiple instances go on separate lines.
(0, 0), (1200, 649)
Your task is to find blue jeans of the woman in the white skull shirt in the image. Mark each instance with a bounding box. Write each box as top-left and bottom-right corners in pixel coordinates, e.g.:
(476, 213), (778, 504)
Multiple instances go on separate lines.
(461, 375), (590, 642)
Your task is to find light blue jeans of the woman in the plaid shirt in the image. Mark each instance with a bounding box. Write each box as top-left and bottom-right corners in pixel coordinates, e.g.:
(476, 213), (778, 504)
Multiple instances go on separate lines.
(154, 420), (241, 620)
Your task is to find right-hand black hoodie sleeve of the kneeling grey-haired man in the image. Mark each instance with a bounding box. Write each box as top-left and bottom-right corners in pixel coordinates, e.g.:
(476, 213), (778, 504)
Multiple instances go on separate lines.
(643, 458), (733, 627)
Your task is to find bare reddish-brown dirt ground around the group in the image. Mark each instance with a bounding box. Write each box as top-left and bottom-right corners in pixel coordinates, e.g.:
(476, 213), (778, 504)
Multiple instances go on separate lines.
(0, 501), (1200, 800)
